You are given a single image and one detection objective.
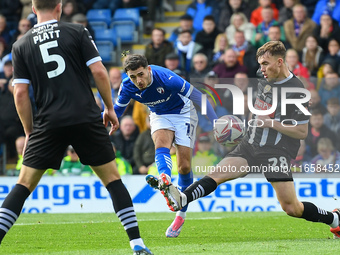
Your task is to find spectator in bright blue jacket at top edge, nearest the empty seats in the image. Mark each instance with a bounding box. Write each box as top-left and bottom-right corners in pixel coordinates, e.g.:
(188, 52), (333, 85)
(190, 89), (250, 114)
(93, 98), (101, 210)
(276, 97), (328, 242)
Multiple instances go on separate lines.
(186, 0), (219, 31)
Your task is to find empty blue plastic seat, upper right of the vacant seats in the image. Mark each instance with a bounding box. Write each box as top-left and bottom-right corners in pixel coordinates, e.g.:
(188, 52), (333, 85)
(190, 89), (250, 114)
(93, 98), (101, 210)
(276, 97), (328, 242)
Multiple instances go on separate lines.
(110, 8), (143, 43)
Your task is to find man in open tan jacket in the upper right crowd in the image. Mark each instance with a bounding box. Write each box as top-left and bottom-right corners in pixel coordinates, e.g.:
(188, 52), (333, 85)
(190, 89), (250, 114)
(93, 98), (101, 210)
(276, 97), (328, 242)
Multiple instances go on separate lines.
(283, 4), (316, 52)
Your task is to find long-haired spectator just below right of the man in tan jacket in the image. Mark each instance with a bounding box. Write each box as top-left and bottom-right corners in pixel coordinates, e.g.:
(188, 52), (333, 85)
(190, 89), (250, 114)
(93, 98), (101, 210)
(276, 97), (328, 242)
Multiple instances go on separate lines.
(301, 35), (324, 77)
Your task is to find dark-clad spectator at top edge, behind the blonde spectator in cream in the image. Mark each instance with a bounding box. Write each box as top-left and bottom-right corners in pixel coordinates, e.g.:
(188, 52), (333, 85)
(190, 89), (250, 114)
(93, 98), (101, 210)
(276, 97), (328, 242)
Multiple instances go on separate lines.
(218, 0), (251, 31)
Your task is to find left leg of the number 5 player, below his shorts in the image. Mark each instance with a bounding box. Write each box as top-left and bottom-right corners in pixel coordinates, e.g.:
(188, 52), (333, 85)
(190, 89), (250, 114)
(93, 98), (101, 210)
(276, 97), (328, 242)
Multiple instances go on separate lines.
(0, 165), (45, 243)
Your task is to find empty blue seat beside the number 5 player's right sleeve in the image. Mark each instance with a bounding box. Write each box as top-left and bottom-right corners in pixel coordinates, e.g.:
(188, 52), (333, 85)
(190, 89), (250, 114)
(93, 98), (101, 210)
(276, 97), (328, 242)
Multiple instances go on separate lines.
(96, 28), (121, 64)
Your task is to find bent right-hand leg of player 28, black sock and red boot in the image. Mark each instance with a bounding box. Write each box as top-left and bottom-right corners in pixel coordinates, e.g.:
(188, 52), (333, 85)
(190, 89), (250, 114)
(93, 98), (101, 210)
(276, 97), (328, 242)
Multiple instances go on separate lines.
(271, 181), (340, 238)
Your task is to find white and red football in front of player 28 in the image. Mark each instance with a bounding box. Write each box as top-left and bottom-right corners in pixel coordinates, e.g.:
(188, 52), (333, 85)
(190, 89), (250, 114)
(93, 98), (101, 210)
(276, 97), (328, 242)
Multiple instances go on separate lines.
(214, 115), (245, 146)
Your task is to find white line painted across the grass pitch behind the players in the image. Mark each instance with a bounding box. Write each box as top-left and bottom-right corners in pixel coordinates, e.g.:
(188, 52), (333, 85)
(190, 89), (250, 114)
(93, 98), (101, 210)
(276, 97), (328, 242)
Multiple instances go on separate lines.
(14, 217), (225, 226)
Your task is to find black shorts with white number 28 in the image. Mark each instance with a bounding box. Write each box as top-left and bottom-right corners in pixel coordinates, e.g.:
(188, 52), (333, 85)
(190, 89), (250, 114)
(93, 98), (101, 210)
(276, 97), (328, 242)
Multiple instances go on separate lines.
(227, 139), (293, 182)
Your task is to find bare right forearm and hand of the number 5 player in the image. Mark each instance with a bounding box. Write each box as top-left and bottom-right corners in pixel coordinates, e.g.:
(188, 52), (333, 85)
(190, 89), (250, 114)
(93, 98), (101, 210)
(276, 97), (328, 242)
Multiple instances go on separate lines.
(89, 61), (119, 135)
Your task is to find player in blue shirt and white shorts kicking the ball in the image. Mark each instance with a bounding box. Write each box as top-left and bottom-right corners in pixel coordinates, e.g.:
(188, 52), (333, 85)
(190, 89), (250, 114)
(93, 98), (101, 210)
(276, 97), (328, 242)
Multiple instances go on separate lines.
(114, 54), (217, 237)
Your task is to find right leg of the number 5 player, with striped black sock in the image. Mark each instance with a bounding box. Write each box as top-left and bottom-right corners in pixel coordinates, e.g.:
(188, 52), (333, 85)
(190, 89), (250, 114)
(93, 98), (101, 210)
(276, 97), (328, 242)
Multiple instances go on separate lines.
(91, 161), (152, 254)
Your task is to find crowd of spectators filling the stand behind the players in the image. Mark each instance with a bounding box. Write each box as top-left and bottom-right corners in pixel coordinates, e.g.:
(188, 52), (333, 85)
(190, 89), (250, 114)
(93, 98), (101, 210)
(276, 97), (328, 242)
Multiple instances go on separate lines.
(0, 0), (340, 175)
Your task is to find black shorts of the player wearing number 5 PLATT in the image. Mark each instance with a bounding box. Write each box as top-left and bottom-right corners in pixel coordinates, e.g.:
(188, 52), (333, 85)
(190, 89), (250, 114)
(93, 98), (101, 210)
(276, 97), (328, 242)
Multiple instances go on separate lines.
(23, 122), (115, 170)
